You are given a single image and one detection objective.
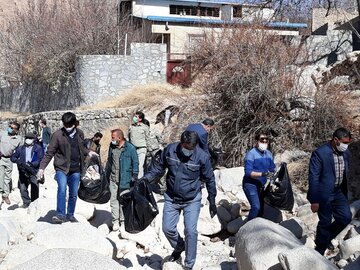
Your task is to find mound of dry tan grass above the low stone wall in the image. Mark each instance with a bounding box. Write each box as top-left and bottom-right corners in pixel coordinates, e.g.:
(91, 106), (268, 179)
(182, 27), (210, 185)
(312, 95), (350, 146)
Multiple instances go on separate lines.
(78, 83), (184, 110)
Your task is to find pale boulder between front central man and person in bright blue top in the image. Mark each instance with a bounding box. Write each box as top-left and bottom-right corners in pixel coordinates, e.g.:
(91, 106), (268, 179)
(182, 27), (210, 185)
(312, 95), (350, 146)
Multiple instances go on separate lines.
(214, 167), (244, 192)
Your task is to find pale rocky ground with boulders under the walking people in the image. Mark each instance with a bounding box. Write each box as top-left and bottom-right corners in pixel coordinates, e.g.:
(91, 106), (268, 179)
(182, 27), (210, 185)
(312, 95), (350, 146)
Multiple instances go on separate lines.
(0, 155), (360, 270)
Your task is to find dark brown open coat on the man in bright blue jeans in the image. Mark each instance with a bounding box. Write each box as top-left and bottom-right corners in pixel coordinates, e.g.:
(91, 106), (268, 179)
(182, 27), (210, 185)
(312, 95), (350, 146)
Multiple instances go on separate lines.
(40, 128), (89, 174)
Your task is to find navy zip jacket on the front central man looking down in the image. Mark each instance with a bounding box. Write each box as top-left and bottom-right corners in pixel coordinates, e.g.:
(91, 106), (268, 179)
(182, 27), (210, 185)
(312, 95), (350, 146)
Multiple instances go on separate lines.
(144, 142), (216, 204)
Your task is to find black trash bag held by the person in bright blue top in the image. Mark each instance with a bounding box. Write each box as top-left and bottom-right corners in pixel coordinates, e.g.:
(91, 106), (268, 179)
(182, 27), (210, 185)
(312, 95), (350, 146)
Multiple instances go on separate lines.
(264, 162), (294, 211)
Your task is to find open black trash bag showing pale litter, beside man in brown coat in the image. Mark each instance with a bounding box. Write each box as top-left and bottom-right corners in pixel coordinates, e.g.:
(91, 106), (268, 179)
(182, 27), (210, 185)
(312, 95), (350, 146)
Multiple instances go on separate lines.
(78, 157), (111, 204)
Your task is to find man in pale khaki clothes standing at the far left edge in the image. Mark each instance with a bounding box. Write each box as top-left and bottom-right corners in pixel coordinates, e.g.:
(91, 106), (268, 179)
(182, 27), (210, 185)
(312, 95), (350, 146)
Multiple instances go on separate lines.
(0, 122), (22, 204)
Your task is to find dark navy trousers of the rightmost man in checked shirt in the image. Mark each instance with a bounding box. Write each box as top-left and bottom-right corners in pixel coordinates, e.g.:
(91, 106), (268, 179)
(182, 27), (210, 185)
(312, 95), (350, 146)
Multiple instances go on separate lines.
(315, 188), (352, 255)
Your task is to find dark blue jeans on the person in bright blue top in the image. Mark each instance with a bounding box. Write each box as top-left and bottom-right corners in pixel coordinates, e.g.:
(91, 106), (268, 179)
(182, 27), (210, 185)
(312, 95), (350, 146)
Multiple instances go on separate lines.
(243, 179), (264, 220)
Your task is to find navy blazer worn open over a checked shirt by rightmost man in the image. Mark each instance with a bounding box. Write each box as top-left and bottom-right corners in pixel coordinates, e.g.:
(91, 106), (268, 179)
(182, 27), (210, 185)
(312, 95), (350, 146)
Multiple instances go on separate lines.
(307, 142), (350, 203)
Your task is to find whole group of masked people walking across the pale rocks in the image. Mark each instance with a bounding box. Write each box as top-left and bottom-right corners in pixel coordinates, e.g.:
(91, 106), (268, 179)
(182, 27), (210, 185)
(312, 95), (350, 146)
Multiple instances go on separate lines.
(0, 111), (351, 269)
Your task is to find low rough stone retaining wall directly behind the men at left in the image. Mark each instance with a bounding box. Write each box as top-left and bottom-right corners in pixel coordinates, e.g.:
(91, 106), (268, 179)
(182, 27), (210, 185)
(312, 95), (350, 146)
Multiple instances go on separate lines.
(21, 108), (135, 138)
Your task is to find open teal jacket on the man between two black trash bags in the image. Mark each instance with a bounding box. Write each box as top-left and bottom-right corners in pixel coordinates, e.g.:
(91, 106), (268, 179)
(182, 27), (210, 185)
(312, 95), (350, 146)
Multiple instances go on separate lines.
(105, 141), (139, 189)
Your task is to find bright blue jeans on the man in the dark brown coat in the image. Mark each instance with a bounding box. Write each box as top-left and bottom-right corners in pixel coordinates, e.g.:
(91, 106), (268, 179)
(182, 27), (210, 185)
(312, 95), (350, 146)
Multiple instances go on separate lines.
(55, 171), (80, 217)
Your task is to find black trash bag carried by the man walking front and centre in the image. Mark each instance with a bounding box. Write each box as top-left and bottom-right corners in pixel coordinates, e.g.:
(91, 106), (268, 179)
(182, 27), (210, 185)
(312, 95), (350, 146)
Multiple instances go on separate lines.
(120, 180), (159, 233)
